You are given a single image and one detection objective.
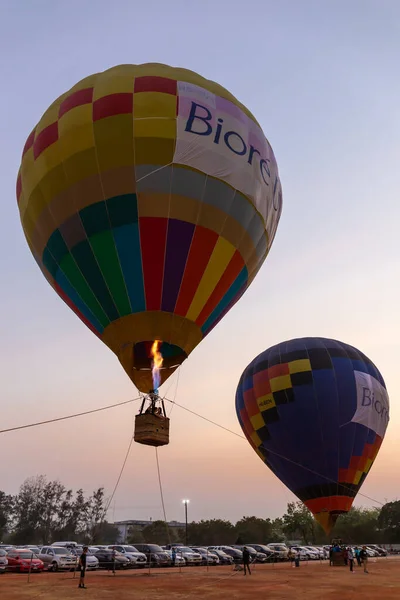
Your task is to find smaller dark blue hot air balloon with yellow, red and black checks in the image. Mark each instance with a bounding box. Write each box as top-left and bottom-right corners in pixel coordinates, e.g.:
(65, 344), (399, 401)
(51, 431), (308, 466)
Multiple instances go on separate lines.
(236, 338), (389, 533)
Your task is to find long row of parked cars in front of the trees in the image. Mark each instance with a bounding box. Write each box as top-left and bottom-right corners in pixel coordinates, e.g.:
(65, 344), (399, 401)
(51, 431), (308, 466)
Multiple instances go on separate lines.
(0, 542), (387, 573)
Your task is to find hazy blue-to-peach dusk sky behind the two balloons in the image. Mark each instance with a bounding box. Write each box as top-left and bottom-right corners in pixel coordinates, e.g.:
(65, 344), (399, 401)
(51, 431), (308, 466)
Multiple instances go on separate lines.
(0, 0), (400, 520)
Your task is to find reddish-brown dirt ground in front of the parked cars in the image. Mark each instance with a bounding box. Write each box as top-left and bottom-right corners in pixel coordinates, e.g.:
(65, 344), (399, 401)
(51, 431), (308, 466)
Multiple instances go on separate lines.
(0, 558), (400, 600)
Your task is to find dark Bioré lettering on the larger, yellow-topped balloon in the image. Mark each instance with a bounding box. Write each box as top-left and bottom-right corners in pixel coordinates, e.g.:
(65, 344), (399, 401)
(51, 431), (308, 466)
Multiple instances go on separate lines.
(185, 100), (278, 191)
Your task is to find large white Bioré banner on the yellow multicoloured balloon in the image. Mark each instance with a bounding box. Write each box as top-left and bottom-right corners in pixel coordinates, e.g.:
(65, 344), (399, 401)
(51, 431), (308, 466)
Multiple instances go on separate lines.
(173, 81), (282, 243)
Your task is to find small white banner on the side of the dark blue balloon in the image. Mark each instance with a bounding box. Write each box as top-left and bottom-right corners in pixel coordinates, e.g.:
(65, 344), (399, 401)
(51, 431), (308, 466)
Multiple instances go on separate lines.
(351, 371), (389, 437)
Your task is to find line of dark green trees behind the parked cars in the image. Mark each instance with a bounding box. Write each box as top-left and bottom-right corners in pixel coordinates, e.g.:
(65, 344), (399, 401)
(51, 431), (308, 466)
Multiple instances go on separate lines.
(0, 475), (400, 545)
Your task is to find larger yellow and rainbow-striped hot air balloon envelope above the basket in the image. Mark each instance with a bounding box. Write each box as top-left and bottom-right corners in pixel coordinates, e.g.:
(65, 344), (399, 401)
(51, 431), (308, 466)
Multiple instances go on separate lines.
(17, 64), (282, 392)
